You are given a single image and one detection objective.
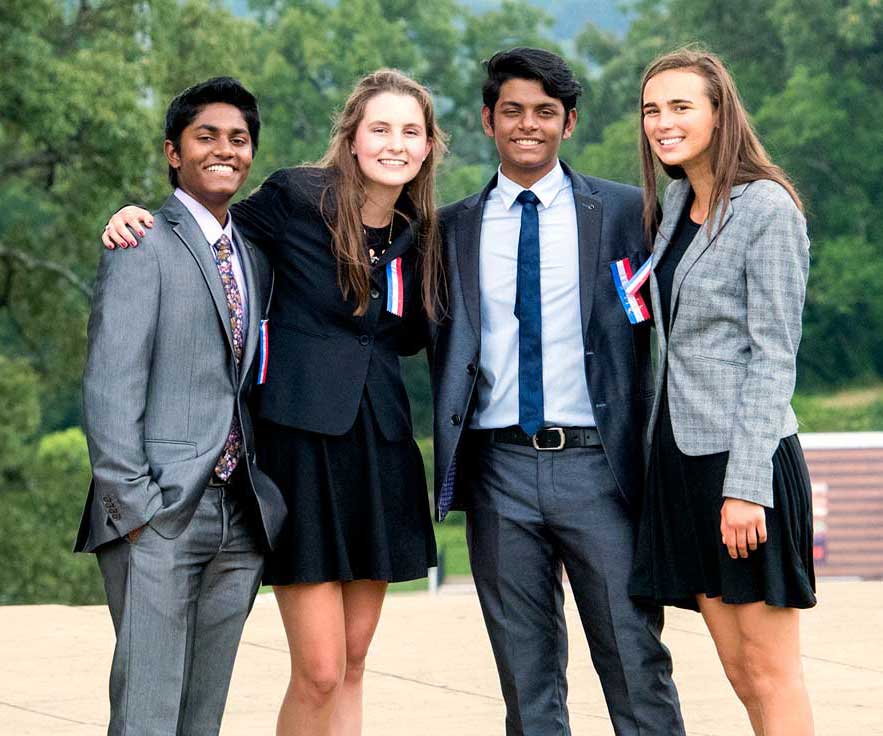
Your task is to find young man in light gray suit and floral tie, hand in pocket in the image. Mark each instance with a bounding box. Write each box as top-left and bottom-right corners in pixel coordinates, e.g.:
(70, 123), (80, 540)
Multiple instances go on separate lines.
(76, 77), (285, 736)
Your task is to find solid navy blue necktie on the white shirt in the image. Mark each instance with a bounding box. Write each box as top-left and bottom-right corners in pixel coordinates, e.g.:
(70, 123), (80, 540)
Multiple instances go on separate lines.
(515, 189), (543, 434)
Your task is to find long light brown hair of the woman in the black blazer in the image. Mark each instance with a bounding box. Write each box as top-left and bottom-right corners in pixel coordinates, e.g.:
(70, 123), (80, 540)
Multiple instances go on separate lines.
(316, 69), (447, 319)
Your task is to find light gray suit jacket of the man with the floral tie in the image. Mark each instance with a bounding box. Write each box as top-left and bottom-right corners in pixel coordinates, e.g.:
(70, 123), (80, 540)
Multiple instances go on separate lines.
(74, 195), (285, 551)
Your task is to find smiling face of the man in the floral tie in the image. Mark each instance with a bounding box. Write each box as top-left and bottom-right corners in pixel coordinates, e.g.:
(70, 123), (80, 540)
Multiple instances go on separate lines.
(165, 102), (253, 224)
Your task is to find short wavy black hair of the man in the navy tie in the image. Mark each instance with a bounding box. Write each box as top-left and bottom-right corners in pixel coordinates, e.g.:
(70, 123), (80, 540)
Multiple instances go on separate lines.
(481, 46), (583, 115)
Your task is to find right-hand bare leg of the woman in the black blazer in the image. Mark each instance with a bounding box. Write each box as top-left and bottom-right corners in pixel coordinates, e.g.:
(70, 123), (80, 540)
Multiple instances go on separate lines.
(331, 580), (387, 736)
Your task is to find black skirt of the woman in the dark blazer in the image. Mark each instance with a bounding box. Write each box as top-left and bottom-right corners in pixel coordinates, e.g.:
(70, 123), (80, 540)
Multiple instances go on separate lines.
(257, 395), (436, 585)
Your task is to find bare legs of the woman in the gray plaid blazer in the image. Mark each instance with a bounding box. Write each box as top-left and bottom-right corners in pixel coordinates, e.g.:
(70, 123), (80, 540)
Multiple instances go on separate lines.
(699, 597), (814, 736)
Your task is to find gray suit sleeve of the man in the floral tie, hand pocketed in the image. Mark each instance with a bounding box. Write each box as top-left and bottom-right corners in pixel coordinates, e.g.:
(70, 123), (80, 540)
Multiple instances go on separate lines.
(83, 242), (162, 536)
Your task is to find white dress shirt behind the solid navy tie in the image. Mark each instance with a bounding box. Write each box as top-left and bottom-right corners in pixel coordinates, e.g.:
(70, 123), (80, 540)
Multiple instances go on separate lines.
(470, 162), (595, 429)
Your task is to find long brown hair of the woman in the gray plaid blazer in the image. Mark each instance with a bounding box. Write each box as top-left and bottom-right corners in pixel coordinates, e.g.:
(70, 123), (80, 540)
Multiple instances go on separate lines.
(638, 46), (803, 242)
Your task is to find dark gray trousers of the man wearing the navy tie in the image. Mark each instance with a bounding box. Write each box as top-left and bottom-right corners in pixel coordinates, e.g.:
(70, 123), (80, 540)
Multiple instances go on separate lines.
(466, 435), (684, 736)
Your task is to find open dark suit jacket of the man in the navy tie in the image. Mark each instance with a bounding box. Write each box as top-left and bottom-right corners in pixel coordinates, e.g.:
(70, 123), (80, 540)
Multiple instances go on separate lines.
(430, 163), (653, 519)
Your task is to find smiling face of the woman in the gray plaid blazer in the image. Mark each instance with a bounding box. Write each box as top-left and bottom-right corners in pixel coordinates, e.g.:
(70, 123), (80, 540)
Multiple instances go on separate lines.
(642, 69), (717, 176)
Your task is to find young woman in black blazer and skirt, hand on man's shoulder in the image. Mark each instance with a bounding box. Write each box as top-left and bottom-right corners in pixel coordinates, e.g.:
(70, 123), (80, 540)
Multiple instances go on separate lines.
(104, 70), (445, 736)
